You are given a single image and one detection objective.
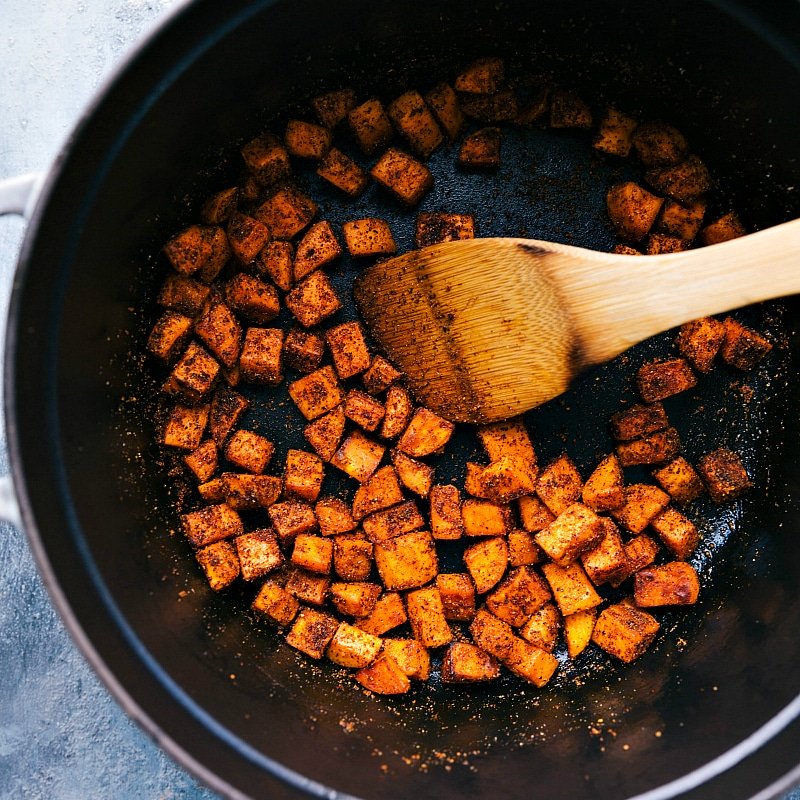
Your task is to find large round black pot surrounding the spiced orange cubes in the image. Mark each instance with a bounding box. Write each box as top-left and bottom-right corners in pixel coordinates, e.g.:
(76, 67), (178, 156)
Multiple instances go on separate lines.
(5, 0), (800, 800)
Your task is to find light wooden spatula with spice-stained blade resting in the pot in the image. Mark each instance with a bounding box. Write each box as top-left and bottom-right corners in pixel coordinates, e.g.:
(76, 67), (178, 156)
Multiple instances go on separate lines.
(354, 220), (800, 422)
